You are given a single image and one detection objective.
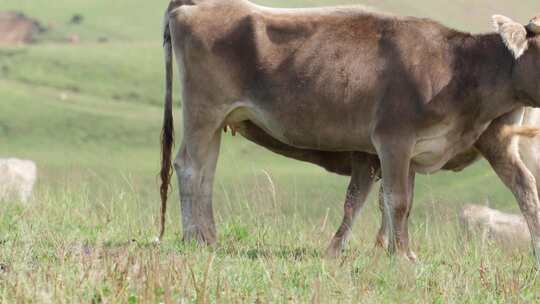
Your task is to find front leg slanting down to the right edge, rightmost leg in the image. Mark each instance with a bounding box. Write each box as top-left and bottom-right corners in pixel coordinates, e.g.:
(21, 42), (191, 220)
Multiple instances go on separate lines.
(477, 127), (540, 263)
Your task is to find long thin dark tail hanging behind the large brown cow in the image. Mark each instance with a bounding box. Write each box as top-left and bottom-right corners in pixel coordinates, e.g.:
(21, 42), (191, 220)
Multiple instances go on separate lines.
(158, 9), (174, 242)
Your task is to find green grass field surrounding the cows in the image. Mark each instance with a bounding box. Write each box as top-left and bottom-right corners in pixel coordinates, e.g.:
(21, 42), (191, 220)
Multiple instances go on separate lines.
(0, 0), (540, 303)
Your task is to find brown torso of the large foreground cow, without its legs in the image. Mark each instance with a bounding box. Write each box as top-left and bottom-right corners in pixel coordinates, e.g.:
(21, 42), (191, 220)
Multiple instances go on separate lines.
(171, 1), (512, 172)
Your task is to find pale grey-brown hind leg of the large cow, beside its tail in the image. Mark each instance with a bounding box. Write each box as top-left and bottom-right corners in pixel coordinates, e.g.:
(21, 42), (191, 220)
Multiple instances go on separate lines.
(174, 93), (224, 245)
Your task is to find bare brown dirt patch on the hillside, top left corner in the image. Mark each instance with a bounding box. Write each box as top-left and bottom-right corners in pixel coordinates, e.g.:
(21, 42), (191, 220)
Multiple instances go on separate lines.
(0, 12), (46, 45)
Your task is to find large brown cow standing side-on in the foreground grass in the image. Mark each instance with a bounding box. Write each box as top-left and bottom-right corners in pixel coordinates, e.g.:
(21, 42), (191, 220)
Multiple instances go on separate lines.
(160, 0), (540, 261)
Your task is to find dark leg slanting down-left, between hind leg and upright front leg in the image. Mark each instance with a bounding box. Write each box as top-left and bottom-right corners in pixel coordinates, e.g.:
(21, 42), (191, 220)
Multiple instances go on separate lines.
(326, 153), (380, 257)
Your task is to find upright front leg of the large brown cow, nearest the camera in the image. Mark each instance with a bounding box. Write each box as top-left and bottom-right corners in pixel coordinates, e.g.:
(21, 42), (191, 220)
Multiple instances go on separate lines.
(374, 136), (416, 261)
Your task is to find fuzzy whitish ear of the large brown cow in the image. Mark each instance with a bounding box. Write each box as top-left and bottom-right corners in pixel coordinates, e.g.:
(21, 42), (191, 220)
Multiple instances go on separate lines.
(492, 15), (529, 59)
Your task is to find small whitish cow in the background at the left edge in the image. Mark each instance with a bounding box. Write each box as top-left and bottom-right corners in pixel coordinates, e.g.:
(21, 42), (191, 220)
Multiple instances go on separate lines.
(0, 158), (37, 202)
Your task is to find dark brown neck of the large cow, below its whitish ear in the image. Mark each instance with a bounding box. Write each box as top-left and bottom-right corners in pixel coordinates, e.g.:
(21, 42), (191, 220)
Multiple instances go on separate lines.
(455, 33), (522, 120)
